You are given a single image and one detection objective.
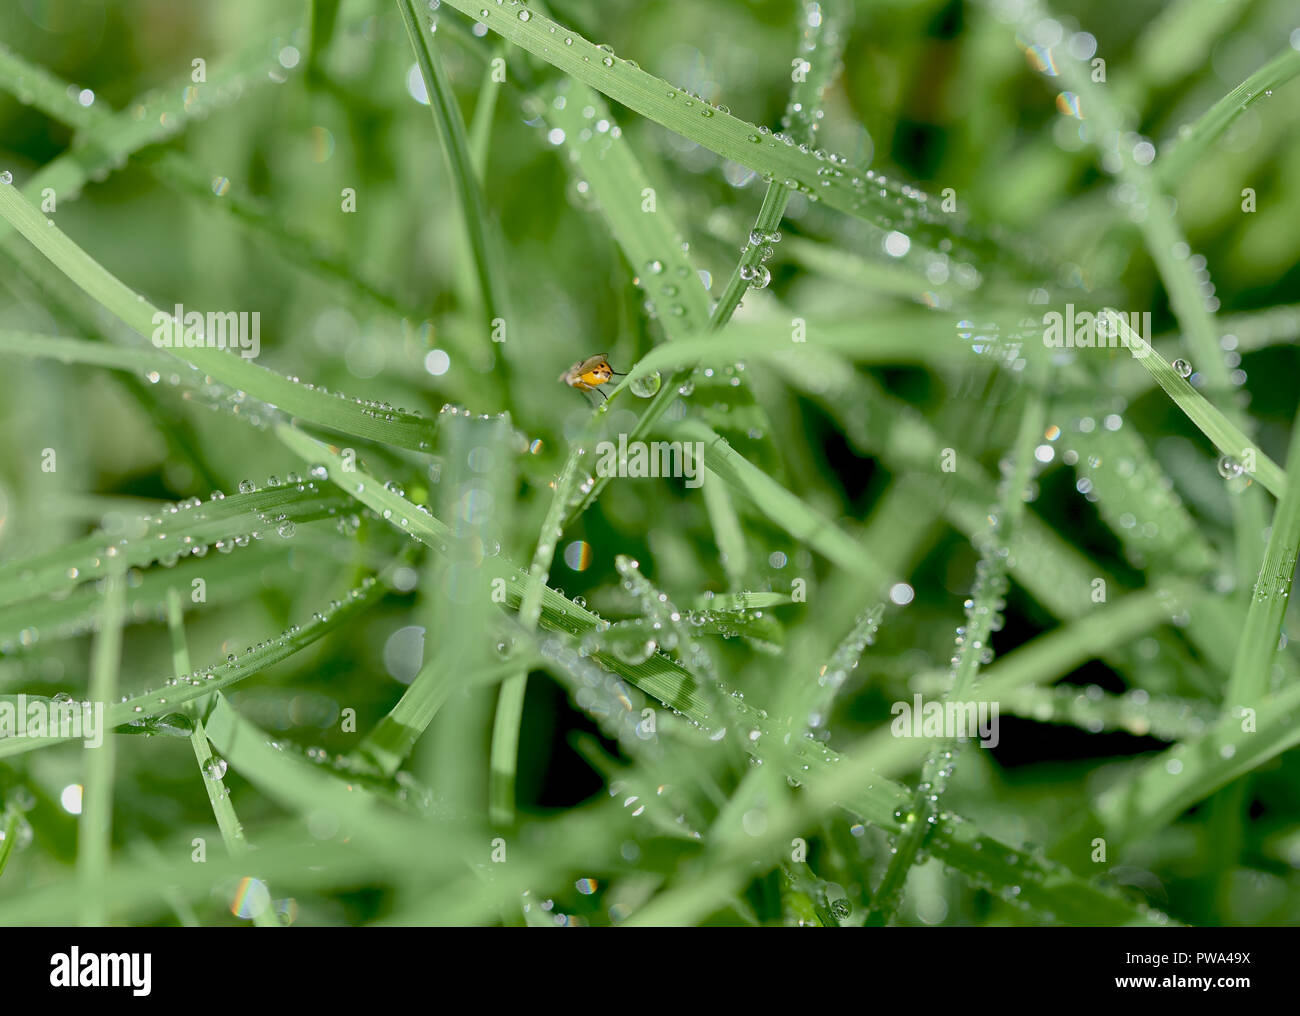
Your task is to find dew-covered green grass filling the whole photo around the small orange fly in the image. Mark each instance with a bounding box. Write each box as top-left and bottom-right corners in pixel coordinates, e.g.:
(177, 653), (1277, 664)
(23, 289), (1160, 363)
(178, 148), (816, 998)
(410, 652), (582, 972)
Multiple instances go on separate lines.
(0, 0), (1300, 926)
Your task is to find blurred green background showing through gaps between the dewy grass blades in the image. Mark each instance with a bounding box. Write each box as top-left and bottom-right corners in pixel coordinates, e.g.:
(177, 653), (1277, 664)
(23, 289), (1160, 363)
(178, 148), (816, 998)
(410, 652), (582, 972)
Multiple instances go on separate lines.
(0, 0), (1300, 924)
